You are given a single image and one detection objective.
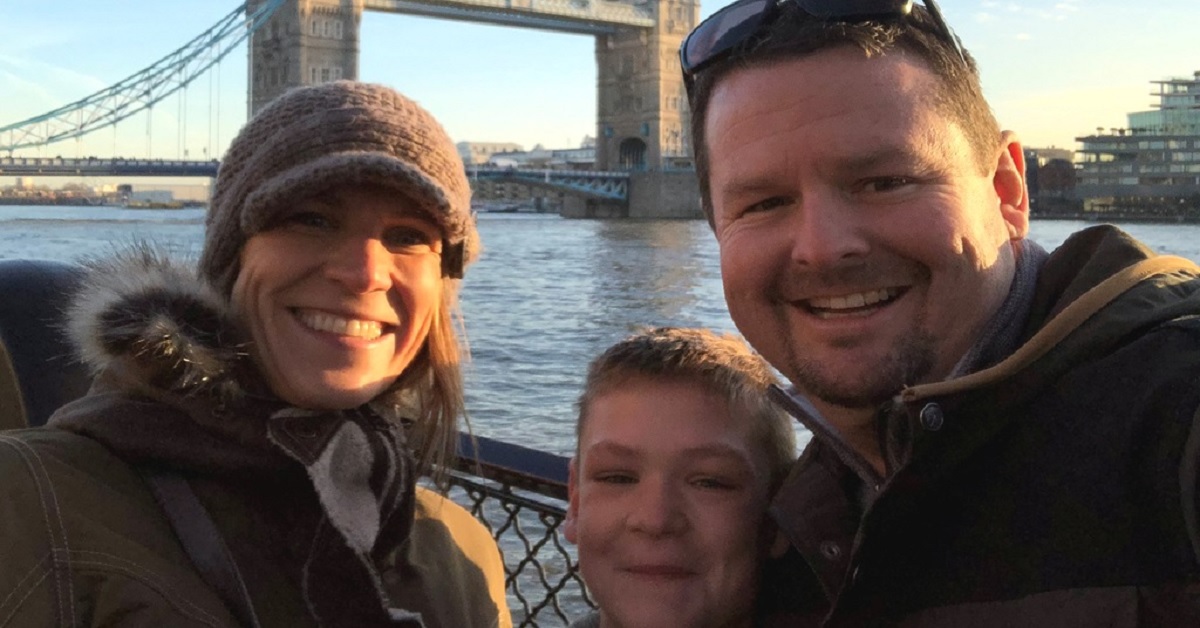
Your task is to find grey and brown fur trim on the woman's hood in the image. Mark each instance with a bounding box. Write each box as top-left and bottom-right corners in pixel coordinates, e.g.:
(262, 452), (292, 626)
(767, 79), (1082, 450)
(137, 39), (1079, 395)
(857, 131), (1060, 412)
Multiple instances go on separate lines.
(67, 243), (245, 391)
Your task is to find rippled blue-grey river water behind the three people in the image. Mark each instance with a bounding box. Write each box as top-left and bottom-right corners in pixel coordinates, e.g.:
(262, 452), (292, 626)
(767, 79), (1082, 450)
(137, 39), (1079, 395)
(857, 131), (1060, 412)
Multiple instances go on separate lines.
(0, 207), (1200, 454)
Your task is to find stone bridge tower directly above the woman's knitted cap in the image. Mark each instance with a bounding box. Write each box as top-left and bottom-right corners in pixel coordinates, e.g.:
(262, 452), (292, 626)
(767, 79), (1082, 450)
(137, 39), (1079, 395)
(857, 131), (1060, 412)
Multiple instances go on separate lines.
(246, 0), (362, 115)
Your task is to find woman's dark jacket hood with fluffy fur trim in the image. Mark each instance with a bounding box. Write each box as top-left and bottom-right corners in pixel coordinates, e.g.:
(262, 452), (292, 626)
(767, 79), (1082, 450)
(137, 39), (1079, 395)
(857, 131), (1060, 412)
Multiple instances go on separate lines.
(49, 244), (289, 473)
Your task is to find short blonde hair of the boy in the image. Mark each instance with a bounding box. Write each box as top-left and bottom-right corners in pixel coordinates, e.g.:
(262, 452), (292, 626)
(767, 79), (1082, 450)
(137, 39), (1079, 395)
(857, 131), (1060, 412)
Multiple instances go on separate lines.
(575, 327), (796, 492)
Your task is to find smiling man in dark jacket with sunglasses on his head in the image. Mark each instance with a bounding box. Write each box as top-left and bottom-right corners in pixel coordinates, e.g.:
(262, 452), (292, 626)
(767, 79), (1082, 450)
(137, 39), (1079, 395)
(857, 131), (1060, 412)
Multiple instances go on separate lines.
(682, 0), (1200, 628)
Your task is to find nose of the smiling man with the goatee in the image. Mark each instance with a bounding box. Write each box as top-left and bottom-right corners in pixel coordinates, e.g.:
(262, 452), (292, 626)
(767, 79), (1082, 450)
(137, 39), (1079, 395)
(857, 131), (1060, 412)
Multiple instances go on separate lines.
(788, 190), (870, 268)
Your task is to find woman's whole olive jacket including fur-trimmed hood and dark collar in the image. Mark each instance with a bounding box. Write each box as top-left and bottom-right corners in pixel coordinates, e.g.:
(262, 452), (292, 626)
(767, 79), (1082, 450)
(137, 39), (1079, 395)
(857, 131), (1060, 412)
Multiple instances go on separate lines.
(0, 255), (511, 628)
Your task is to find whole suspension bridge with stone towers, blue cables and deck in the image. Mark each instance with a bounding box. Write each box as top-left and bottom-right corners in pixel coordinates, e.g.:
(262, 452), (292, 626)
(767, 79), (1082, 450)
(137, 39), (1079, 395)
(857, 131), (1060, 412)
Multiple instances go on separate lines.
(0, 0), (701, 217)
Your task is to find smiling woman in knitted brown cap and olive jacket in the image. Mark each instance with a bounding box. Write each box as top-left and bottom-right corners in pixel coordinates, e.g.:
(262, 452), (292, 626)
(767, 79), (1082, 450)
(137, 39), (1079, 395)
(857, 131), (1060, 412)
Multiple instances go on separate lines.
(0, 82), (511, 627)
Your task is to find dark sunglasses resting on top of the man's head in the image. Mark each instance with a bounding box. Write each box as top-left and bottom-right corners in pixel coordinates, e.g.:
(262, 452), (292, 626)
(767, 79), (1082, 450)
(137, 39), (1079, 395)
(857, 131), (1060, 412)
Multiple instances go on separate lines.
(679, 0), (967, 85)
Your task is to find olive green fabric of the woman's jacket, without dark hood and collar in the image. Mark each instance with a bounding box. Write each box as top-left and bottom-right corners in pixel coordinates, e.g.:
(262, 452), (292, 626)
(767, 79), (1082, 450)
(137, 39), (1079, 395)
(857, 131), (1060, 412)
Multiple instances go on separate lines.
(0, 429), (511, 628)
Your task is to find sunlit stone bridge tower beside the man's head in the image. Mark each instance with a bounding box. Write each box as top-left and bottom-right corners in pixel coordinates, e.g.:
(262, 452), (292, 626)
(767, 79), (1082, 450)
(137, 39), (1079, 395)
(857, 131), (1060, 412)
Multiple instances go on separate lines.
(596, 0), (700, 171)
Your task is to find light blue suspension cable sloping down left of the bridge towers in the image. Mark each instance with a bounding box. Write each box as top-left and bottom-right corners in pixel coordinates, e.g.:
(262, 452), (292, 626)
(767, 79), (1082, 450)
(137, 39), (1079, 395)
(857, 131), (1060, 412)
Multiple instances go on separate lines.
(0, 0), (284, 154)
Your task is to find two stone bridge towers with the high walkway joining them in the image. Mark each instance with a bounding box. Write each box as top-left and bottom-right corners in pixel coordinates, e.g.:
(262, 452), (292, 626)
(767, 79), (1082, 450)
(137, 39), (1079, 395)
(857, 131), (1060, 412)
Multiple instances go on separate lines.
(246, 0), (700, 171)
